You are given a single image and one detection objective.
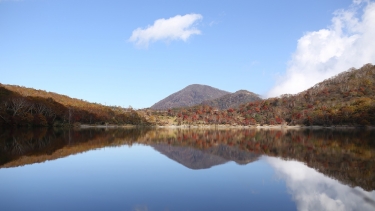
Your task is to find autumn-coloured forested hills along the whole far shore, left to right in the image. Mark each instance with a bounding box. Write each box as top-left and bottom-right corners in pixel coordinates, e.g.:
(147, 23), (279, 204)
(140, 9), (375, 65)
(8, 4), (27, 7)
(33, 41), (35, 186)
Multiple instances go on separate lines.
(0, 64), (375, 126)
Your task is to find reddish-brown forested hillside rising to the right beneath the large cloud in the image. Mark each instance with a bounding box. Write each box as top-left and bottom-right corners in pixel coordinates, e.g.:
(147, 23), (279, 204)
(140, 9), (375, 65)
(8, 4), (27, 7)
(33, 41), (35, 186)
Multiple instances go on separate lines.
(164, 64), (375, 126)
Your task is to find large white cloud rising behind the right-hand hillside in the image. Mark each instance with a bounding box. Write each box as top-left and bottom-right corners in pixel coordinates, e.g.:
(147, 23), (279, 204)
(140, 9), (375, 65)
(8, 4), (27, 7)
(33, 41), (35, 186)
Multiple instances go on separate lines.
(267, 0), (375, 97)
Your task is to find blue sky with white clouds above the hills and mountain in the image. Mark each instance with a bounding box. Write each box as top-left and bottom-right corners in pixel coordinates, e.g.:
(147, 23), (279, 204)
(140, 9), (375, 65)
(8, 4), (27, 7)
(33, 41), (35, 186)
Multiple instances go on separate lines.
(0, 0), (375, 108)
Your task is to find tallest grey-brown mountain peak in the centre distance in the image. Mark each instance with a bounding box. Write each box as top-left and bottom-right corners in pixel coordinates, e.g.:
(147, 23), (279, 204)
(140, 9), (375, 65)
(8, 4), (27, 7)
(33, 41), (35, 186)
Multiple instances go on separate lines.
(150, 84), (229, 110)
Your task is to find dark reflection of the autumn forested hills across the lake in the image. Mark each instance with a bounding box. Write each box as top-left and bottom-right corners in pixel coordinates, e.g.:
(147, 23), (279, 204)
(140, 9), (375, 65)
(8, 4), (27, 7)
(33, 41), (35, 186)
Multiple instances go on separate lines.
(0, 127), (375, 191)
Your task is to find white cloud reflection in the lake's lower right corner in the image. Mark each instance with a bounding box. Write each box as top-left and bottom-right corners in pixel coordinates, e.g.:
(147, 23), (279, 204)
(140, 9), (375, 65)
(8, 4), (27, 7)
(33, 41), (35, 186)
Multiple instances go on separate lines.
(264, 157), (375, 211)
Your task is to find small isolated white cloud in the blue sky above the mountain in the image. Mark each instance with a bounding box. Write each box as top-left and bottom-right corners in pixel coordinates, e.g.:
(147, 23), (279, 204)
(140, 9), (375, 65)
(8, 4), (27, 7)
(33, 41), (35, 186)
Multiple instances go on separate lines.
(129, 14), (203, 47)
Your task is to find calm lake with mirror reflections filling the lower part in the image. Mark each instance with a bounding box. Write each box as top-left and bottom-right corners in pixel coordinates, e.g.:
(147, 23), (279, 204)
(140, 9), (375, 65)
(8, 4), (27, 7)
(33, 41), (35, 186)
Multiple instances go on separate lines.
(0, 128), (375, 211)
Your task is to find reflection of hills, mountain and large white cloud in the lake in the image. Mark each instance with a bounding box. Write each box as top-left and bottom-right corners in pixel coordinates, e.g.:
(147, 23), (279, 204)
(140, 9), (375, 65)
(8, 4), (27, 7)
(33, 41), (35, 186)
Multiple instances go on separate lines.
(0, 128), (375, 210)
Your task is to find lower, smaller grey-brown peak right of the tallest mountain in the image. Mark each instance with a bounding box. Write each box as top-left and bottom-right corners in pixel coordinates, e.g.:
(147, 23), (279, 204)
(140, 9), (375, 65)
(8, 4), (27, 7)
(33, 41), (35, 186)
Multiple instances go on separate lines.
(202, 90), (262, 110)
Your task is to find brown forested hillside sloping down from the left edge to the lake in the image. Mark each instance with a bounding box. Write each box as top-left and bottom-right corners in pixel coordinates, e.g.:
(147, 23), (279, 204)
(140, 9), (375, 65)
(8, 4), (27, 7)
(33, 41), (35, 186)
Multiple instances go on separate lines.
(0, 84), (149, 127)
